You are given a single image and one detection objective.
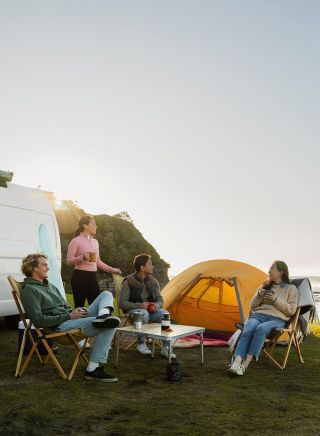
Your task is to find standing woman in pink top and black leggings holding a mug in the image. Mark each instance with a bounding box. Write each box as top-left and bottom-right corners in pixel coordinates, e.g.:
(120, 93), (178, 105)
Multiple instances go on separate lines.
(67, 215), (121, 307)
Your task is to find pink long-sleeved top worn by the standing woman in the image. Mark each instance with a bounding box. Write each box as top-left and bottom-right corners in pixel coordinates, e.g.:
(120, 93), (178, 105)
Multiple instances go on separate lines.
(67, 234), (115, 273)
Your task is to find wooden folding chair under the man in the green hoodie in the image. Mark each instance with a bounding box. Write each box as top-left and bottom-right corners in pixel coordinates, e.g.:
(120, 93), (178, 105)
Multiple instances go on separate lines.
(8, 276), (88, 380)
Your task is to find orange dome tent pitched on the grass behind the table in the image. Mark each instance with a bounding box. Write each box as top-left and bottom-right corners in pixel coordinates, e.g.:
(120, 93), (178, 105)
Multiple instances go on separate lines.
(161, 260), (267, 332)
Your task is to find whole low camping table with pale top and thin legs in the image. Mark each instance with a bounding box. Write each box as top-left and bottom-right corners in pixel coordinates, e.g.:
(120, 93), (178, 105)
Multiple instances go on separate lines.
(115, 323), (205, 367)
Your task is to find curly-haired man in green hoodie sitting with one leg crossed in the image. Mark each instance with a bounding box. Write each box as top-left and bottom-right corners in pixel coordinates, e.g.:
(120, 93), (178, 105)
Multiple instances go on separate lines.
(21, 254), (120, 382)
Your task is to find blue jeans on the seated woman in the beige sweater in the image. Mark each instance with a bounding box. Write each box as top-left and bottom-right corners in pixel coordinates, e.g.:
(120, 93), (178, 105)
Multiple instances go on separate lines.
(234, 313), (286, 360)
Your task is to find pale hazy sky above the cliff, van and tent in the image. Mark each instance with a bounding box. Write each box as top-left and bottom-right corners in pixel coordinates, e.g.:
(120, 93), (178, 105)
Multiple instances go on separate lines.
(0, 0), (320, 275)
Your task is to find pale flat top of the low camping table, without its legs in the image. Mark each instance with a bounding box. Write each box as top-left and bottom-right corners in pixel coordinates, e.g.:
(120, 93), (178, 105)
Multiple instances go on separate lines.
(117, 323), (205, 340)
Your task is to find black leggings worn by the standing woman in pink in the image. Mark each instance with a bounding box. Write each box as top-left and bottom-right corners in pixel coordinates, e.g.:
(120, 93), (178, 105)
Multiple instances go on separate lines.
(71, 269), (100, 307)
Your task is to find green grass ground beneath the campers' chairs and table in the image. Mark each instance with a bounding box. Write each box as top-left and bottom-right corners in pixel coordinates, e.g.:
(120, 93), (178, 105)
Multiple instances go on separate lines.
(0, 319), (320, 436)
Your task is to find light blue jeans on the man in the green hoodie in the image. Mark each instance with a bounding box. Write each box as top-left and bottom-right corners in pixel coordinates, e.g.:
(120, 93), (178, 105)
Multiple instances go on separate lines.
(57, 291), (116, 363)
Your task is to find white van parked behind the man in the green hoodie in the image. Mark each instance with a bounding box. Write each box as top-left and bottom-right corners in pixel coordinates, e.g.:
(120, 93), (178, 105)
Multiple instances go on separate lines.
(0, 183), (65, 316)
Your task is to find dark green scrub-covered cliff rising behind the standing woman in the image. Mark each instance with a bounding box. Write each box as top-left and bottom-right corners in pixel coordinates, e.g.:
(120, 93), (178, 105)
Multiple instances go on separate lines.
(60, 213), (170, 290)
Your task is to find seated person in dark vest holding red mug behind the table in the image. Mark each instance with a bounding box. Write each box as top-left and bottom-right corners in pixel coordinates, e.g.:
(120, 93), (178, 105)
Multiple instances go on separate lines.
(119, 254), (176, 359)
